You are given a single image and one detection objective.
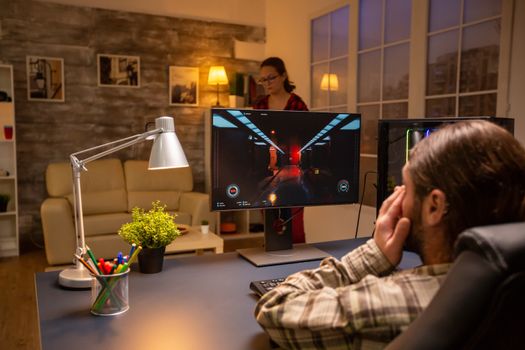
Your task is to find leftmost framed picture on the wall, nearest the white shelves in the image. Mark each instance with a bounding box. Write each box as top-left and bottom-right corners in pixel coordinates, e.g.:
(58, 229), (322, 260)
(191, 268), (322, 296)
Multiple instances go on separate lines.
(26, 56), (66, 102)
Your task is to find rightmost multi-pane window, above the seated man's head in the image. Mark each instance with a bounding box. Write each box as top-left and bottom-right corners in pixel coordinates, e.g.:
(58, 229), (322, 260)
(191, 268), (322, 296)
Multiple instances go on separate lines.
(425, 0), (502, 117)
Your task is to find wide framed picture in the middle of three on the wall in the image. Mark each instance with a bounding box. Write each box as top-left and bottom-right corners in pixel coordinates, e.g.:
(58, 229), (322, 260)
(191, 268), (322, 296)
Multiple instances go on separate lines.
(97, 54), (140, 88)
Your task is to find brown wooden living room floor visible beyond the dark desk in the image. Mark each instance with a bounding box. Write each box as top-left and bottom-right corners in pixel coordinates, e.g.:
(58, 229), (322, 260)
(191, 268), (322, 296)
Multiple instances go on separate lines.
(0, 238), (262, 350)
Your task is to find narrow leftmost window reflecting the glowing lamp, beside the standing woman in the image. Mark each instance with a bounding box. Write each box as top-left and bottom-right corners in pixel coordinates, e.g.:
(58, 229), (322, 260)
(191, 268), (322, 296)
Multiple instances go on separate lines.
(310, 6), (349, 112)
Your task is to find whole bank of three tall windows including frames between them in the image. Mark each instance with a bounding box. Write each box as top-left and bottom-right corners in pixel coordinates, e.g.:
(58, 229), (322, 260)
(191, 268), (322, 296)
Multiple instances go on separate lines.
(310, 0), (514, 206)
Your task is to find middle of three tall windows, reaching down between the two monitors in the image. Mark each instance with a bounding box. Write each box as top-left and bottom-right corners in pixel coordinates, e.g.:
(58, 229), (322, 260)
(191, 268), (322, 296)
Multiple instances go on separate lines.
(357, 0), (411, 206)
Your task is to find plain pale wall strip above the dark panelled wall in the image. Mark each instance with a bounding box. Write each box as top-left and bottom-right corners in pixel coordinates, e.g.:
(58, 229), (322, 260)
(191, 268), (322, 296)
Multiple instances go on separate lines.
(39, 0), (265, 27)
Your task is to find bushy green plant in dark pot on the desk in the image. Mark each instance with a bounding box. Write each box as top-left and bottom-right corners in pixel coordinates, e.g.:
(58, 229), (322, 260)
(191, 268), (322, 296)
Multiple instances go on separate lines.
(118, 201), (180, 273)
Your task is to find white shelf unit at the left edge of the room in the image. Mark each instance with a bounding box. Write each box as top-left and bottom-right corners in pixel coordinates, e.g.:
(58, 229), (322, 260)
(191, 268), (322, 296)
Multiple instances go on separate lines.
(0, 64), (19, 257)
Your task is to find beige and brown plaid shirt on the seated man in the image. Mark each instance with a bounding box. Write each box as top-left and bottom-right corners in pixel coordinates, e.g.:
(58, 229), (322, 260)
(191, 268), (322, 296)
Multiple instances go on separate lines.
(255, 240), (450, 349)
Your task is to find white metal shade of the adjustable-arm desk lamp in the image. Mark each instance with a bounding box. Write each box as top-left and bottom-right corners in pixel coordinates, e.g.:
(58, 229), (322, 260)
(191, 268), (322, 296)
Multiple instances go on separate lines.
(148, 117), (189, 170)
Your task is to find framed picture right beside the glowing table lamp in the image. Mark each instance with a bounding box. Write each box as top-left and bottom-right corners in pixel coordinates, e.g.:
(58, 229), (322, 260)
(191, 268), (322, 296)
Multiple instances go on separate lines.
(169, 66), (199, 107)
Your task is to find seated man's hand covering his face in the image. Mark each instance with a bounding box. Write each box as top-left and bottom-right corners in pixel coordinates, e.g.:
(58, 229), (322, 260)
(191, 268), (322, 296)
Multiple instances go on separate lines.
(374, 186), (410, 266)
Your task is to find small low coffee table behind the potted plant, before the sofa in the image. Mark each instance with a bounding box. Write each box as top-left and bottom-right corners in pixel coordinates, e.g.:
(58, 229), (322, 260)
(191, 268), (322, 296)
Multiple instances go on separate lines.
(166, 226), (224, 254)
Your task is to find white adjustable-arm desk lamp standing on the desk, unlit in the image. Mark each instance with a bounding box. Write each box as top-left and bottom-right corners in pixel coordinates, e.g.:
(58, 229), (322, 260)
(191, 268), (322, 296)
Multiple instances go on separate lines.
(58, 117), (188, 288)
